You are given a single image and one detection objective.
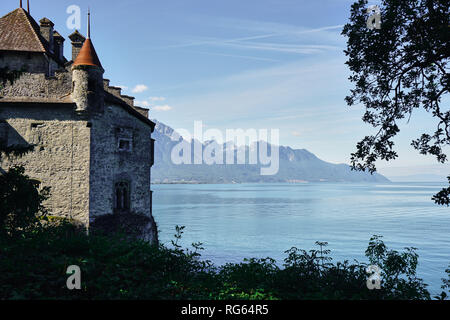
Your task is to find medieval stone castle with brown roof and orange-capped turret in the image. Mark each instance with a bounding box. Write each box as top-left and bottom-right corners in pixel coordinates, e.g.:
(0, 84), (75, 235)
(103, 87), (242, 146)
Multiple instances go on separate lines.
(0, 3), (157, 243)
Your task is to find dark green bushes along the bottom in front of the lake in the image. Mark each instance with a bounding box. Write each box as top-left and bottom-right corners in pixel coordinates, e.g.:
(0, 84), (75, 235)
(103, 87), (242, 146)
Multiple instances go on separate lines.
(0, 222), (440, 300)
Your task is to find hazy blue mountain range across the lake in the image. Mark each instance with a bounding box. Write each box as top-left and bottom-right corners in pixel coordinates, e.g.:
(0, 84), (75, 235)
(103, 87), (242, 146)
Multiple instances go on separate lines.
(152, 120), (389, 183)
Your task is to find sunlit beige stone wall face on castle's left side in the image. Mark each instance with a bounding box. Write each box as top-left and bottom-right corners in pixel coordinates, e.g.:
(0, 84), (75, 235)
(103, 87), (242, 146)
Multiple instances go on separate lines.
(0, 103), (91, 226)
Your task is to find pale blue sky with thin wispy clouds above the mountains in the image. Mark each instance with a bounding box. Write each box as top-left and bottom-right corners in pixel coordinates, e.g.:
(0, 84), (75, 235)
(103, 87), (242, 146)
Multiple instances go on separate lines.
(0, 0), (450, 177)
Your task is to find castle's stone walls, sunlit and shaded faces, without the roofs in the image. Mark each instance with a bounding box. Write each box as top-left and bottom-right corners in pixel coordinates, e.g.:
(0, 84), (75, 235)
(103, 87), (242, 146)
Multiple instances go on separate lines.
(0, 52), (157, 243)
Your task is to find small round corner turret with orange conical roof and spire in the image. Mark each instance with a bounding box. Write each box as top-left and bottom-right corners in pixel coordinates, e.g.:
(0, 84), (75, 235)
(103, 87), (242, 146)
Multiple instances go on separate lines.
(72, 12), (105, 113)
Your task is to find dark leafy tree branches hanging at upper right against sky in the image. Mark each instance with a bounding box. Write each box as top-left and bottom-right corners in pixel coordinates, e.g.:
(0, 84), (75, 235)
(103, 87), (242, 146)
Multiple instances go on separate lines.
(342, 0), (450, 205)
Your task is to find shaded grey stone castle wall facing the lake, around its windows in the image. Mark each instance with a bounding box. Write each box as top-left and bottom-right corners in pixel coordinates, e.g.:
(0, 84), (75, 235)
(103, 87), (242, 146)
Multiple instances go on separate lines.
(90, 105), (151, 219)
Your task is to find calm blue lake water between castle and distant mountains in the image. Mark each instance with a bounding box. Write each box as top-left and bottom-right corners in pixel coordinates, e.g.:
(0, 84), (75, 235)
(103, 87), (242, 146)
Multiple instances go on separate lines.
(153, 183), (450, 293)
